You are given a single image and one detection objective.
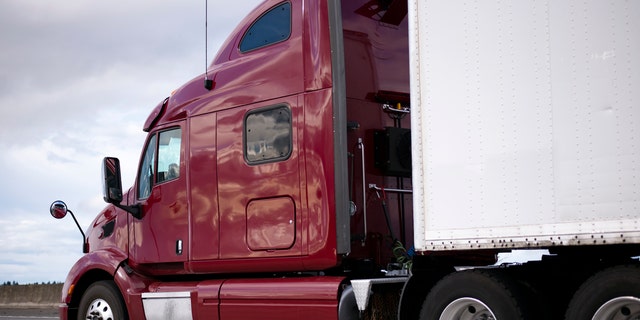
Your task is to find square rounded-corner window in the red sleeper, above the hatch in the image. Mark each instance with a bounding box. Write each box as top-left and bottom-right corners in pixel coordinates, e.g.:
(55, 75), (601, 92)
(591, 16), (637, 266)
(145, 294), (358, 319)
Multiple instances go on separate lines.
(244, 106), (293, 164)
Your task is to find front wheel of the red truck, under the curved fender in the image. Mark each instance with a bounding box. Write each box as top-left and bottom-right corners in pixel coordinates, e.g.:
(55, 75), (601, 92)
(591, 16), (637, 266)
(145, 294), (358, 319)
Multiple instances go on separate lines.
(78, 281), (128, 320)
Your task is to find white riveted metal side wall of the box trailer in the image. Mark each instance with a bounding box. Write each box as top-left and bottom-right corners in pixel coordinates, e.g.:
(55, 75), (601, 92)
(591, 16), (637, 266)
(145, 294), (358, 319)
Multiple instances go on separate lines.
(409, 0), (640, 250)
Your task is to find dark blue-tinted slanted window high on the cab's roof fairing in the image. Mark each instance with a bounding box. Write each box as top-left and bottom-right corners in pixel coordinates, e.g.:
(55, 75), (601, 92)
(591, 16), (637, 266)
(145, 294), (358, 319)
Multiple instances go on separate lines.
(240, 2), (291, 53)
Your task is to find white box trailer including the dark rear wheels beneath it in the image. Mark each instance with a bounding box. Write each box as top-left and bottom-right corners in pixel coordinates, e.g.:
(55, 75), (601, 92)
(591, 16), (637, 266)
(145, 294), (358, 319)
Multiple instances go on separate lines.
(401, 0), (640, 320)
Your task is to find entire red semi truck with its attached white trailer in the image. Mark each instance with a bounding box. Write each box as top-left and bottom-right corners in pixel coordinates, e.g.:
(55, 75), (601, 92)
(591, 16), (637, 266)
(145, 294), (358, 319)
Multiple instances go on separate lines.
(51, 0), (640, 320)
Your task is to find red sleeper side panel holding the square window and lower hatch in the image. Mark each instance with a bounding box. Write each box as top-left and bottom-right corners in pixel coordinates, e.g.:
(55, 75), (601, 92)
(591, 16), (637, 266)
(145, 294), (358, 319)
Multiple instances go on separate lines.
(217, 96), (305, 259)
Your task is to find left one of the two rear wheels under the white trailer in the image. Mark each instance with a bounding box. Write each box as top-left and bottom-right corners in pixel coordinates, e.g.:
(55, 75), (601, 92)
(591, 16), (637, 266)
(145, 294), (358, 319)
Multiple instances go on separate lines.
(420, 270), (536, 320)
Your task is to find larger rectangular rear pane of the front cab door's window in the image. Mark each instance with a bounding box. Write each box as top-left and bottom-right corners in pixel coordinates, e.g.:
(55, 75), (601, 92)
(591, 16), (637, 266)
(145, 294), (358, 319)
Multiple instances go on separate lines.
(156, 129), (182, 183)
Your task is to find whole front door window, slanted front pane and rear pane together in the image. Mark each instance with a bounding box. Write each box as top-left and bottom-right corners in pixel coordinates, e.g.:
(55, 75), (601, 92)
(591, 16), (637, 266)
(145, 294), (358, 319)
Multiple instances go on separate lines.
(138, 128), (182, 199)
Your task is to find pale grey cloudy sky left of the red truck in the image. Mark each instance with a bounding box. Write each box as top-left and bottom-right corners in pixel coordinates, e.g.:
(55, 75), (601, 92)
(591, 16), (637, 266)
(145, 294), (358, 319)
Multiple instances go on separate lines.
(0, 0), (261, 284)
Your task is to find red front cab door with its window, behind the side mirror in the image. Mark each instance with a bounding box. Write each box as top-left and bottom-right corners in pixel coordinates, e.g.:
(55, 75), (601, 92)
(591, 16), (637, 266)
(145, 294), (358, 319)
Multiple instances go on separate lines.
(130, 122), (189, 264)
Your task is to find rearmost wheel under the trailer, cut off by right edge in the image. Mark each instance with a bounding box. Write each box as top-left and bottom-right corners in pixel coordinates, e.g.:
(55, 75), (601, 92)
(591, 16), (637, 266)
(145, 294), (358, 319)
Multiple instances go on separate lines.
(565, 265), (640, 320)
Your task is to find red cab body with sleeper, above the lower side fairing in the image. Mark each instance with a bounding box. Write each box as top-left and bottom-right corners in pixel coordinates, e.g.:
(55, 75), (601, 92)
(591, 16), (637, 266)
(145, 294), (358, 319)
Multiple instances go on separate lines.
(100, 1), (410, 275)
